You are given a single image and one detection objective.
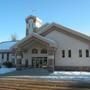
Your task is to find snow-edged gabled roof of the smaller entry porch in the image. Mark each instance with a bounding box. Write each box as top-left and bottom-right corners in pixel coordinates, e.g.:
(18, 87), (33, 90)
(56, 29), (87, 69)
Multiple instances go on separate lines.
(16, 32), (57, 47)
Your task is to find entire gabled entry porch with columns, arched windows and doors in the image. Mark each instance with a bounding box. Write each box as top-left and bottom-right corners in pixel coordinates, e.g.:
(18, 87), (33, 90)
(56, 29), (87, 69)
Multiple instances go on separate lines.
(16, 34), (56, 71)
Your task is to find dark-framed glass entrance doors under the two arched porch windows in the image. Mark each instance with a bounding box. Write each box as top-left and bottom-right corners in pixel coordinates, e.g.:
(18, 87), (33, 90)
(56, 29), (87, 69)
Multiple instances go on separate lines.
(32, 57), (47, 68)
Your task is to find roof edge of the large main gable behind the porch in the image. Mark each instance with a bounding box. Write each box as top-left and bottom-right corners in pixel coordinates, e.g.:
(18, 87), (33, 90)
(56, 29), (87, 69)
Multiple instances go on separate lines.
(38, 23), (90, 40)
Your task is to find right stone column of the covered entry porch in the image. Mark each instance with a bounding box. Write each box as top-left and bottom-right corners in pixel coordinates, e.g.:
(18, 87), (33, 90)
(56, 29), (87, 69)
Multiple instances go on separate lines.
(48, 47), (55, 71)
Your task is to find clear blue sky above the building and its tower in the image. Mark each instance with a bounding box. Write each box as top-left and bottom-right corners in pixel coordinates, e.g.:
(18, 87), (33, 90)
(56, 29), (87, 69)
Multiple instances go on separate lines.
(0, 0), (90, 42)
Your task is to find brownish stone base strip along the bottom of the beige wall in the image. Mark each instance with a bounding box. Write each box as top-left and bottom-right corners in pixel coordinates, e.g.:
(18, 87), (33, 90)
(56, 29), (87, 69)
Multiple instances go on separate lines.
(55, 66), (90, 71)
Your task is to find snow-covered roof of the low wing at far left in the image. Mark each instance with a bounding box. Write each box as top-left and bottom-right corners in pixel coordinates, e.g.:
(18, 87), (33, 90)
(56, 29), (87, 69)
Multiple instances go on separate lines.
(0, 41), (17, 51)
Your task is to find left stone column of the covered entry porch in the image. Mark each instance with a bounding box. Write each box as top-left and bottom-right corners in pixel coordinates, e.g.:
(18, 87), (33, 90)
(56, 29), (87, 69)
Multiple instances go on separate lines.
(16, 50), (22, 70)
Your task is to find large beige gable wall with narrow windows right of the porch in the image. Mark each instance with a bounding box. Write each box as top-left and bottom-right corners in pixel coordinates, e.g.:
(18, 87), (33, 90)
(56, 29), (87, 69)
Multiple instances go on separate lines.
(46, 31), (90, 66)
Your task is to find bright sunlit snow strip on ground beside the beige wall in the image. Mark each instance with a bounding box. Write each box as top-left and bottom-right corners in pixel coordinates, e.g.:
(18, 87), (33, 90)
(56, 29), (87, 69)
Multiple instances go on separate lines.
(48, 71), (90, 81)
